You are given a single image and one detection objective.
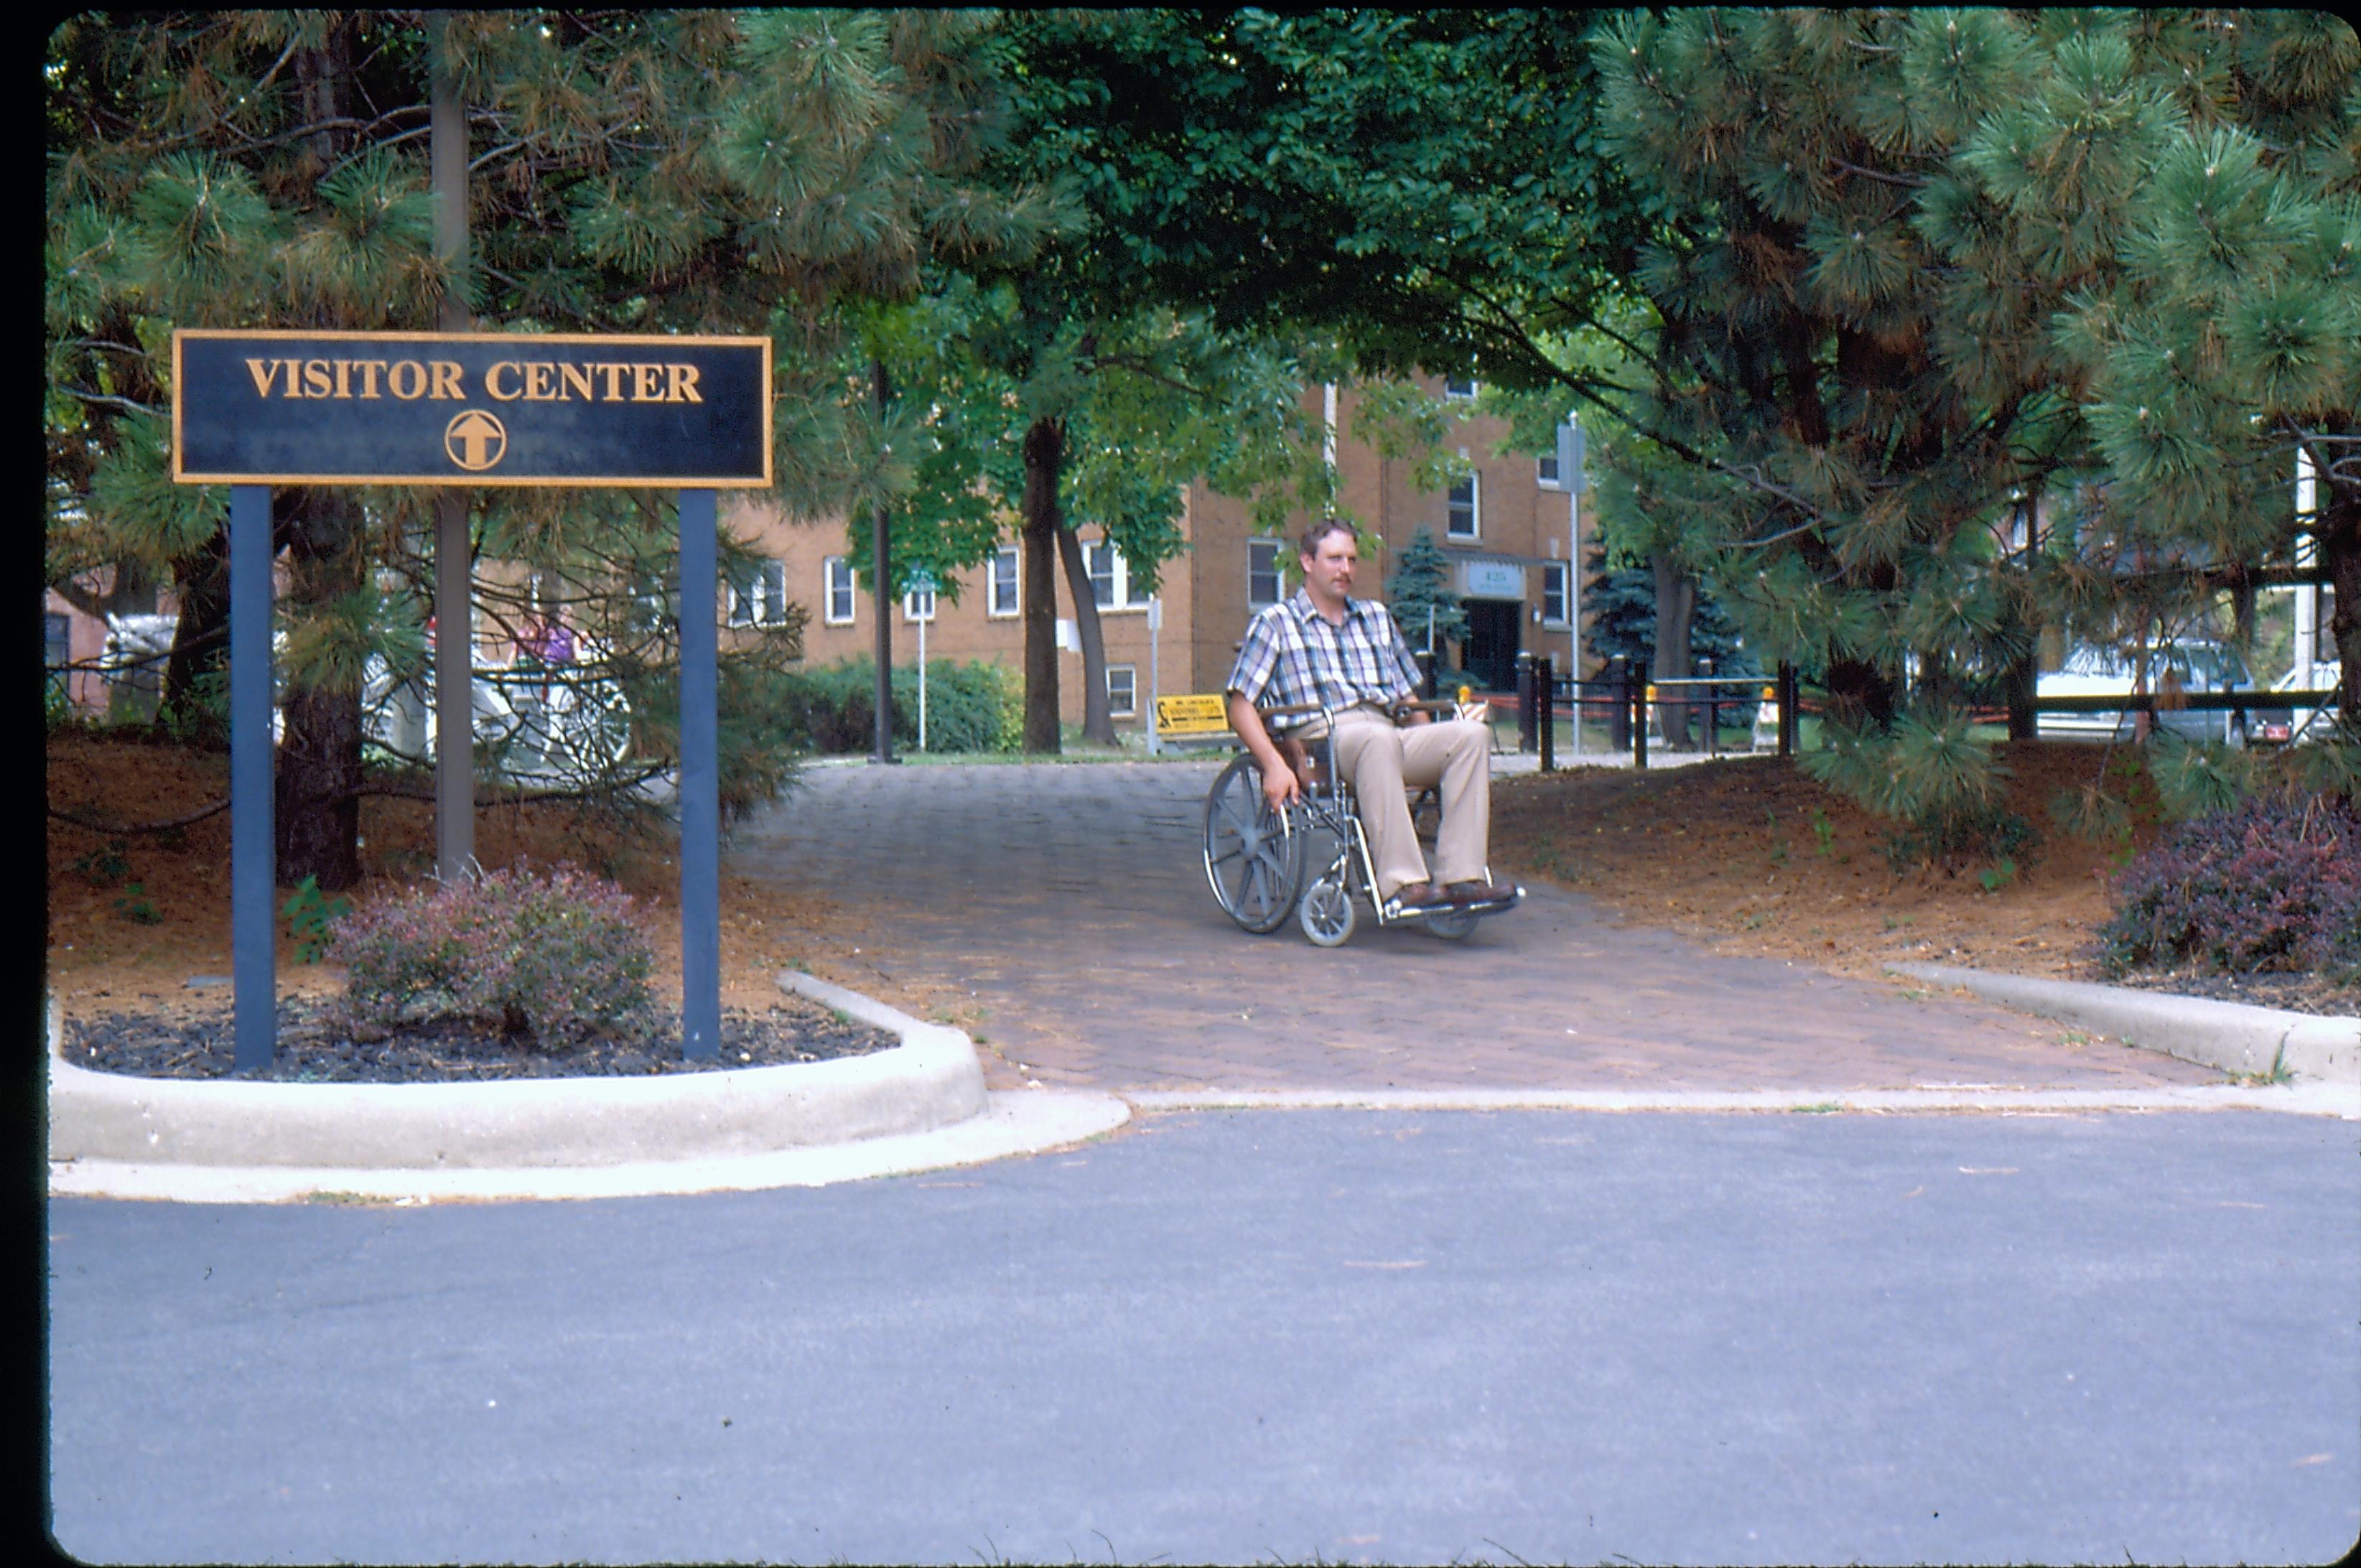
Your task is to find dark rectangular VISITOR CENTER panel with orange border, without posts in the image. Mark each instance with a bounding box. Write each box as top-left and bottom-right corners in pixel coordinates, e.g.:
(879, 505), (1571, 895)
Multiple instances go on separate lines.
(172, 328), (772, 489)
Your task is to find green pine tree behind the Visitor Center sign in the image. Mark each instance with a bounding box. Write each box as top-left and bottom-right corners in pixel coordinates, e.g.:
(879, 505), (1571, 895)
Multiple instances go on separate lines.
(45, 11), (1062, 869)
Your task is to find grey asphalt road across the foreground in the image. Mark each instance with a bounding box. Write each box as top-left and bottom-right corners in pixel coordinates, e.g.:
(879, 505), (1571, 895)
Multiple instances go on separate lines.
(47, 1112), (2361, 1563)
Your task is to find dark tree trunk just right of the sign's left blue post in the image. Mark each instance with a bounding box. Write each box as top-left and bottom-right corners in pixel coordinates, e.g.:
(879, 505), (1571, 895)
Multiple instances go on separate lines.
(271, 489), (366, 892)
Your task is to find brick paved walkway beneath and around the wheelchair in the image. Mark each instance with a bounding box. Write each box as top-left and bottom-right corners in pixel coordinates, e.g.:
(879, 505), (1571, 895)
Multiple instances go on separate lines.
(730, 762), (2217, 1091)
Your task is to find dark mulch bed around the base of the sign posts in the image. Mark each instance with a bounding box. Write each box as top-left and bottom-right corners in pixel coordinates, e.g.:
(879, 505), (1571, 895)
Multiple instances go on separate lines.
(61, 997), (902, 1084)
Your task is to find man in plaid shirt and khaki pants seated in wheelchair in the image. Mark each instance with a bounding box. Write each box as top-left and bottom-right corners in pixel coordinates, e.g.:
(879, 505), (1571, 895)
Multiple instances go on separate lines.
(1228, 520), (1516, 914)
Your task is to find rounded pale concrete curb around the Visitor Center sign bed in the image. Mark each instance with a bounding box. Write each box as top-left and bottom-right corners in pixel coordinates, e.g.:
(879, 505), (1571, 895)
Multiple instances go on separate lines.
(50, 973), (1129, 1202)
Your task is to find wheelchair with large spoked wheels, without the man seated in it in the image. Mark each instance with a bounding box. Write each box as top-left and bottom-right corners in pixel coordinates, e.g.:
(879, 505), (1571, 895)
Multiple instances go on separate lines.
(1204, 701), (1525, 947)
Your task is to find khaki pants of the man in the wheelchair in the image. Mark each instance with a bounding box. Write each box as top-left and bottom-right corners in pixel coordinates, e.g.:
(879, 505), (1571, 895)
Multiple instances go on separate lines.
(1336, 709), (1492, 900)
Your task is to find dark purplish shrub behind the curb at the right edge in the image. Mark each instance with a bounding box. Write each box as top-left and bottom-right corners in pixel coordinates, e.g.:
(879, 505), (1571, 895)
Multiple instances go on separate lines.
(2099, 791), (2361, 985)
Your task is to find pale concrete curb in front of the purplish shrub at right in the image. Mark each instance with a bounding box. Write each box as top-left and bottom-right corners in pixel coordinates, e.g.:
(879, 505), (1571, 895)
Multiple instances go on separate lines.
(1886, 963), (2361, 1086)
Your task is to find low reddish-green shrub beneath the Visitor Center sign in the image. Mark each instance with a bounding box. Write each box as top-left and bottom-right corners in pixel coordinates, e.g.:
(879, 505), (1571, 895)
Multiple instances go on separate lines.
(328, 867), (654, 1046)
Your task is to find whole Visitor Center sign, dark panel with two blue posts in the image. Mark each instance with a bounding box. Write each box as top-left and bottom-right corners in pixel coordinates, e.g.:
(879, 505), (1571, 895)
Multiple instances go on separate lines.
(187, 330), (772, 1072)
